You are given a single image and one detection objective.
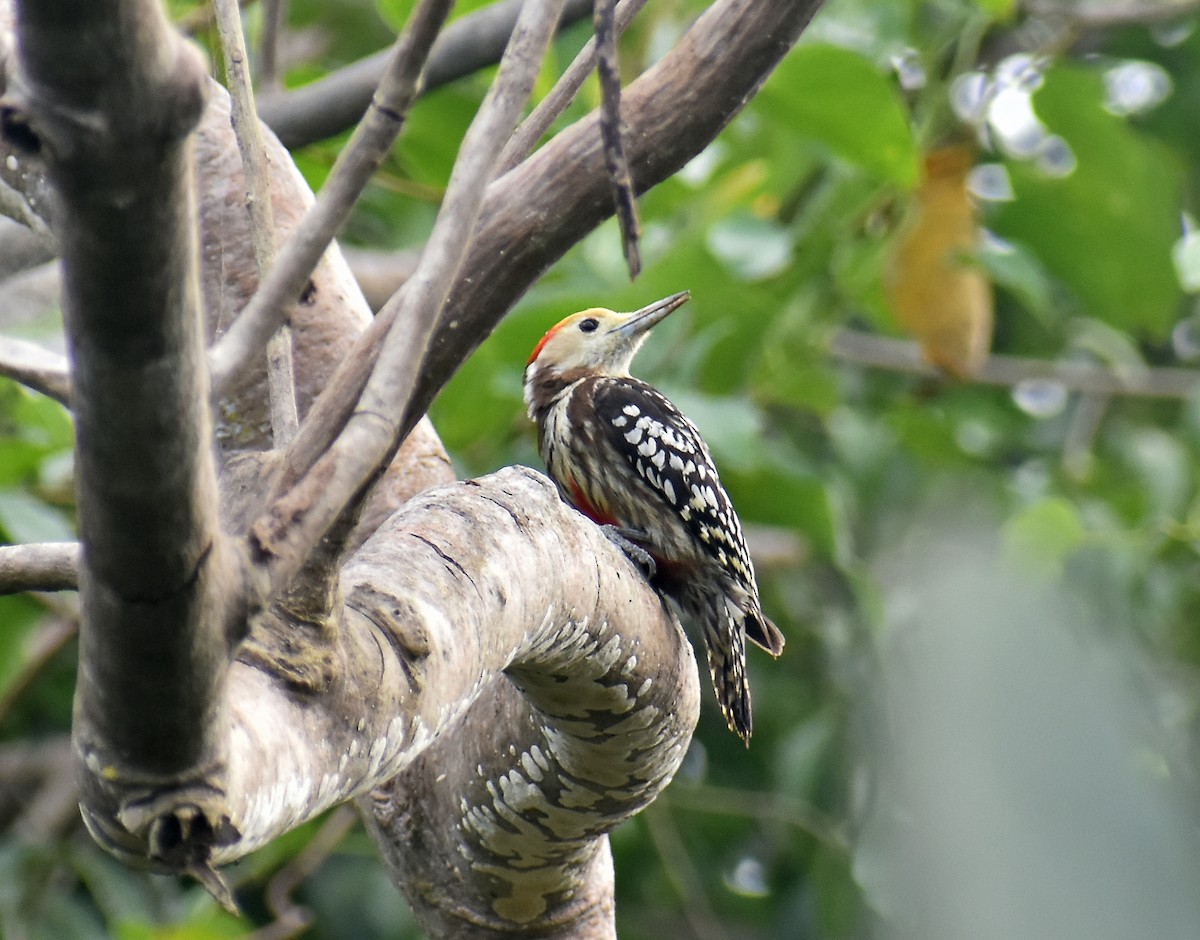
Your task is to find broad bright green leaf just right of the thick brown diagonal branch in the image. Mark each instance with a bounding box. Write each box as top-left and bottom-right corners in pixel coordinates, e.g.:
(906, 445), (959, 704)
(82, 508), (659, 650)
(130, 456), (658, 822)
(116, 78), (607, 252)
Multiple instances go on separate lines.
(758, 46), (917, 188)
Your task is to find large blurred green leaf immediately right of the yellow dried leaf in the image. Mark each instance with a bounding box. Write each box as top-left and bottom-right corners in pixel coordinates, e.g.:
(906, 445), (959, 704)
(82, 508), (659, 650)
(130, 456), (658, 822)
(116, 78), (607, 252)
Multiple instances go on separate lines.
(995, 66), (1182, 339)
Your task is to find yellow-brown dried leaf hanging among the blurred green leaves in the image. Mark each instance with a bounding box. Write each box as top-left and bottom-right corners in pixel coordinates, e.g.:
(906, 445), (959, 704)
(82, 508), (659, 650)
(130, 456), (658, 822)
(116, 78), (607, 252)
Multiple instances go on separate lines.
(887, 146), (992, 378)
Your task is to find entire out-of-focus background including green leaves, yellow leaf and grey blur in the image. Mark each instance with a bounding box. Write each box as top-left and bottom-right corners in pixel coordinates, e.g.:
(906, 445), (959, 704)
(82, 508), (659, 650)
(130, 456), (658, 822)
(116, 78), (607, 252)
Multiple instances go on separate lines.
(0, 0), (1200, 940)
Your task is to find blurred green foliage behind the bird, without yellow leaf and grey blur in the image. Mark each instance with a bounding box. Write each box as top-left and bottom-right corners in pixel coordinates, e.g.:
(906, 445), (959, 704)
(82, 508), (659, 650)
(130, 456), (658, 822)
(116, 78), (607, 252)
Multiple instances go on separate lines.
(7, 0), (1200, 940)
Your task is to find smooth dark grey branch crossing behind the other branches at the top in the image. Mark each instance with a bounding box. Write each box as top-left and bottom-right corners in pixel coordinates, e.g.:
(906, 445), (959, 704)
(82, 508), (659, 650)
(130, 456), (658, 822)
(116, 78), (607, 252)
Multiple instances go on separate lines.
(258, 0), (592, 149)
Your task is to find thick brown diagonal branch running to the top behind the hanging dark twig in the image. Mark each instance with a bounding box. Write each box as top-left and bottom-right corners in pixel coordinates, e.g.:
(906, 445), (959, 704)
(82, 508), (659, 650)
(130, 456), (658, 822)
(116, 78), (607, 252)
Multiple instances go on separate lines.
(265, 0), (821, 506)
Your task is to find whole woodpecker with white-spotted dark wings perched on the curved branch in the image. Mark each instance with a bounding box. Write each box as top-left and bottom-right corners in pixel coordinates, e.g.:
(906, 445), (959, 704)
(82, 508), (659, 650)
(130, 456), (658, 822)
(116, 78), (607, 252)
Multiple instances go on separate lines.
(524, 291), (784, 744)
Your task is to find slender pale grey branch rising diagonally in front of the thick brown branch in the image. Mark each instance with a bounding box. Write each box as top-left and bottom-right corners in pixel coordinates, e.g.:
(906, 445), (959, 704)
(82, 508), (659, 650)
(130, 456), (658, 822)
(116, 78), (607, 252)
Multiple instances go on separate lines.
(252, 0), (563, 587)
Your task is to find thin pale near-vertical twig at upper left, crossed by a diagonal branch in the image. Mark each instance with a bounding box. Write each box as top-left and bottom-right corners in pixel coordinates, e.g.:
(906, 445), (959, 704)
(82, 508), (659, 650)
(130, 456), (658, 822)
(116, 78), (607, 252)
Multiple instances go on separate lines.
(215, 0), (300, 448)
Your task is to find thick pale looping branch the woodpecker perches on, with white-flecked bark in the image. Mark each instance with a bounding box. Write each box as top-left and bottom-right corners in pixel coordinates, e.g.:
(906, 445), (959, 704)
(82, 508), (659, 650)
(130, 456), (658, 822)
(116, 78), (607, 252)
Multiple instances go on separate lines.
(85, 468), (700, 936)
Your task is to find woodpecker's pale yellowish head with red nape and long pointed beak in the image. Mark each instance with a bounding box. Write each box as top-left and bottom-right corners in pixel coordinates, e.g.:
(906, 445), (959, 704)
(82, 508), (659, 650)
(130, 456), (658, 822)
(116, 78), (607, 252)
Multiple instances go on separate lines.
(526, 291), (691, 388)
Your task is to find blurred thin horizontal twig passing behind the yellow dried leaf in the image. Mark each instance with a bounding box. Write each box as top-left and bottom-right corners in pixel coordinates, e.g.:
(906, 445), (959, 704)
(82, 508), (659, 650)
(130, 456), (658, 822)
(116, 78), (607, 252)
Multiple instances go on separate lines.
(828, 329), (1200, 399)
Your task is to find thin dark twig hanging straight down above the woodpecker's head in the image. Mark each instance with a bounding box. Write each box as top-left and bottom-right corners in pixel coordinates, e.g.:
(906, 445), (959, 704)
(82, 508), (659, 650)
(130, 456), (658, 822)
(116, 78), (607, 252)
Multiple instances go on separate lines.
(594, 0), (642, 281)
